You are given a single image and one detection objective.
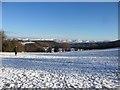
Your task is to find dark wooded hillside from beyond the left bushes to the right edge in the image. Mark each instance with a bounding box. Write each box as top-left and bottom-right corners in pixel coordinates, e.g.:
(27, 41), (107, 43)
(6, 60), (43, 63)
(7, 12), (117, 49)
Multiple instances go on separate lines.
(25, 40), (120, 52)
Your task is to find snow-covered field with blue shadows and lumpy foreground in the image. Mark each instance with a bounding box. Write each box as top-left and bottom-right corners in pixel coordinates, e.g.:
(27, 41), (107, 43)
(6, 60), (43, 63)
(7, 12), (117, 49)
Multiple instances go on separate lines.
(0, 49), (119, 88)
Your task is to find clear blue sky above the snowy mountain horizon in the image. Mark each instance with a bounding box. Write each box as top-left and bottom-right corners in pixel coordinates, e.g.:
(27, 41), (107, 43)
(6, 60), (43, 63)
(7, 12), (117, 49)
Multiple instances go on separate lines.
(2, 2), (118, 40)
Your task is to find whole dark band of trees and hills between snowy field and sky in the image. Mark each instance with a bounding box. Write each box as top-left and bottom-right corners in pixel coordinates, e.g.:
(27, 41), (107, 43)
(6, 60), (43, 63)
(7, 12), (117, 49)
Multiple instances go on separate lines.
(0, 32), (120, 52)
